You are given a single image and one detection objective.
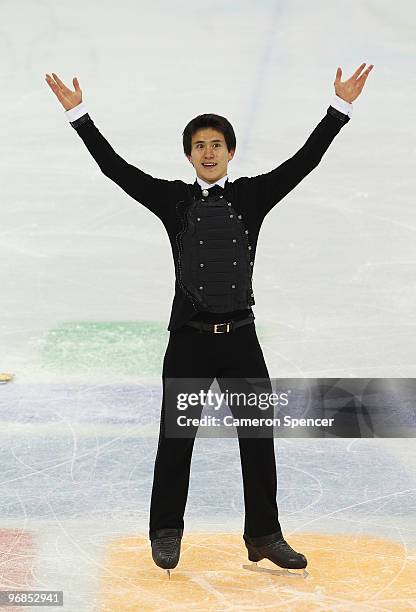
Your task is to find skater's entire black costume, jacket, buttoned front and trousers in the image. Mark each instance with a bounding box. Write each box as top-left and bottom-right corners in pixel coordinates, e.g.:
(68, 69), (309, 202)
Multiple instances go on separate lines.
(71, 106), (349, 538)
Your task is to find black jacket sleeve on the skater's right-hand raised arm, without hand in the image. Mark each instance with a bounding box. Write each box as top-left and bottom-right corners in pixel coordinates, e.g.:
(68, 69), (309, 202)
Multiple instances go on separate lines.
(246, 106), (350, 216)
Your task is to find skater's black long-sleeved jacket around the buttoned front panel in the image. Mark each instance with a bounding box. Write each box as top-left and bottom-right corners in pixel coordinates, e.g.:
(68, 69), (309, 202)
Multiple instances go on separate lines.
(71, 106), (350, 331)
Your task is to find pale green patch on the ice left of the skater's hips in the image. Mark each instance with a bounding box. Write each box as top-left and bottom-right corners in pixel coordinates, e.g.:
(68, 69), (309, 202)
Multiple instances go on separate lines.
(40, 321), (169, 376)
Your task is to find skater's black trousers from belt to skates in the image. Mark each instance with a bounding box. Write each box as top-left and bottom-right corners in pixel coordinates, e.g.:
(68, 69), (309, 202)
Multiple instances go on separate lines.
(149, 323), (280, 537)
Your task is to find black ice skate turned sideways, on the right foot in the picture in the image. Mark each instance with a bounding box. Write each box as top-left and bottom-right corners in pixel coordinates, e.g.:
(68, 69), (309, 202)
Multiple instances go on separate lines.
(243, 532), (308, 578)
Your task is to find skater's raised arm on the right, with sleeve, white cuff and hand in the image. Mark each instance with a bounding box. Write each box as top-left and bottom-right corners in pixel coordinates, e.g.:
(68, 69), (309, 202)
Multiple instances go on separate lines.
(244, 64), (373, 215)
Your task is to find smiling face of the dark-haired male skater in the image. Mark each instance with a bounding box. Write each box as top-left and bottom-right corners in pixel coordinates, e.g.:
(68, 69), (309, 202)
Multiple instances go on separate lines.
(187, 128), (234, 183)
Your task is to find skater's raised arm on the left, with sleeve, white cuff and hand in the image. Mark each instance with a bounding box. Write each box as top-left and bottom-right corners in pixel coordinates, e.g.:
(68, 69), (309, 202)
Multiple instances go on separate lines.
(45, 73), (180, 219)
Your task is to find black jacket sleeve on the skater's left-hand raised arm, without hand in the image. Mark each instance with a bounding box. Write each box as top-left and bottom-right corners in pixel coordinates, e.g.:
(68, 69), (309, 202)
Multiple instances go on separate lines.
(70, 113), (181, 220)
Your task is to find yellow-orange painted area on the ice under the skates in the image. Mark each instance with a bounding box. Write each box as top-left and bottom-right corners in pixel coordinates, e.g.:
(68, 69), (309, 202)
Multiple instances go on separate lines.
(97, 533), (416, 612)
